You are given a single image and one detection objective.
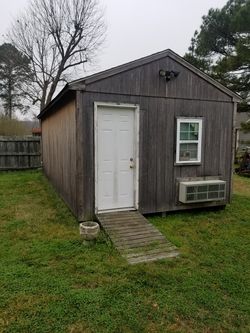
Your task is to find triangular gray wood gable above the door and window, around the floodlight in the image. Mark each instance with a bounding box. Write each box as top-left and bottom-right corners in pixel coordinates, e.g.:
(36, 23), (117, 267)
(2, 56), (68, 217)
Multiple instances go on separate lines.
(88, 57), (232, 101)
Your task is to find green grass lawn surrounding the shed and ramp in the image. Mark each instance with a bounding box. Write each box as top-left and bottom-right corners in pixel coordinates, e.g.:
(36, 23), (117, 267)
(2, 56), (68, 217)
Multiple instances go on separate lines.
(0, 171), (250, 333)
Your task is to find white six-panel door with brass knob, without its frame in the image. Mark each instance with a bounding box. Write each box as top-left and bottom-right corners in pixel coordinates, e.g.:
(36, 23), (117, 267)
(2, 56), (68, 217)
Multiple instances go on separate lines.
(96, 106), (136, 211)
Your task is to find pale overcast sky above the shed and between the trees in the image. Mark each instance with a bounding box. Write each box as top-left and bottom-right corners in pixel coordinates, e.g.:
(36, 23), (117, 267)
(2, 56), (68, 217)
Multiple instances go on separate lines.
(0, 0), (227, 72)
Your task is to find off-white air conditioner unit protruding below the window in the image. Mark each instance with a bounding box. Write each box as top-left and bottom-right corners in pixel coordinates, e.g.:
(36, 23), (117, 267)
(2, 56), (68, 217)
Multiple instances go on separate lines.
(179, 180), (226, 203)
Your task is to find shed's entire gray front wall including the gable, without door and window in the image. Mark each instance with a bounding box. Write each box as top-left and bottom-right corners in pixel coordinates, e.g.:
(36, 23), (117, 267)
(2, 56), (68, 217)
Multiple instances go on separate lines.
(74, 57), (233, 219)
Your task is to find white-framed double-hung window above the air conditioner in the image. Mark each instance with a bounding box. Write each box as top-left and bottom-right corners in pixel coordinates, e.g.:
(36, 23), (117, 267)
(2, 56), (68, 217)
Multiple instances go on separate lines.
(176, 118), (202, 164)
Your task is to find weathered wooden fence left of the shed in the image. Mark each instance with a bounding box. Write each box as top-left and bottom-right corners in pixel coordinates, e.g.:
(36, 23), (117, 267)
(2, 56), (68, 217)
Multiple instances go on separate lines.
(0, 137), (41, 170)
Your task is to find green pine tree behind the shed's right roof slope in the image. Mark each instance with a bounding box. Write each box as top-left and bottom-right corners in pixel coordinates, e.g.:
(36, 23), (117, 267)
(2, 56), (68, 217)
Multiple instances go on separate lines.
(185, 0), (250, 111)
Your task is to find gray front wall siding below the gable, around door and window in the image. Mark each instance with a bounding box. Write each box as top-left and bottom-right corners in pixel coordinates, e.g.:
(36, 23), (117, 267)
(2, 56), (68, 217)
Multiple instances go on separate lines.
(77, 92), (233, 218)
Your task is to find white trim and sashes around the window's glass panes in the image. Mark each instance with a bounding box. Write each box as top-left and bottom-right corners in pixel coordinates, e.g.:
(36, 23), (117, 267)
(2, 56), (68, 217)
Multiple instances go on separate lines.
(176, 118), (203, 164)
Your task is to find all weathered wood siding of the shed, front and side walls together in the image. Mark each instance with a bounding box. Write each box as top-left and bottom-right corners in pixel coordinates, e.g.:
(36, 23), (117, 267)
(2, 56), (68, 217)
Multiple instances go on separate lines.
(42, 53), (236, 221)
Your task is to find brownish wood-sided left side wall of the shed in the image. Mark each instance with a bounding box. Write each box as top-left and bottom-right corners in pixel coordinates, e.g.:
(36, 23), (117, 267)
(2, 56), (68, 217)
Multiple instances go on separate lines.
(42, 99), (78, 215)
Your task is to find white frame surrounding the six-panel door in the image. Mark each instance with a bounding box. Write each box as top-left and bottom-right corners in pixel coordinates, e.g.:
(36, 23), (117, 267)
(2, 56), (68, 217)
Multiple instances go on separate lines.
(94, 102), (140, 213)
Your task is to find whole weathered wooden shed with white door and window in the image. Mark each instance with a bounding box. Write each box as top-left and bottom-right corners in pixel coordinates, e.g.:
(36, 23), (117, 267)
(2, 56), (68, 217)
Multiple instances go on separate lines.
(38, 50), (240, 221)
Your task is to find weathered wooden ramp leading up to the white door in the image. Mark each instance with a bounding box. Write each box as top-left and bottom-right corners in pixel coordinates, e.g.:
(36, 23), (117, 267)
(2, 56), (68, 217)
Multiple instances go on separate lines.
(97, 211), (179, 264)
